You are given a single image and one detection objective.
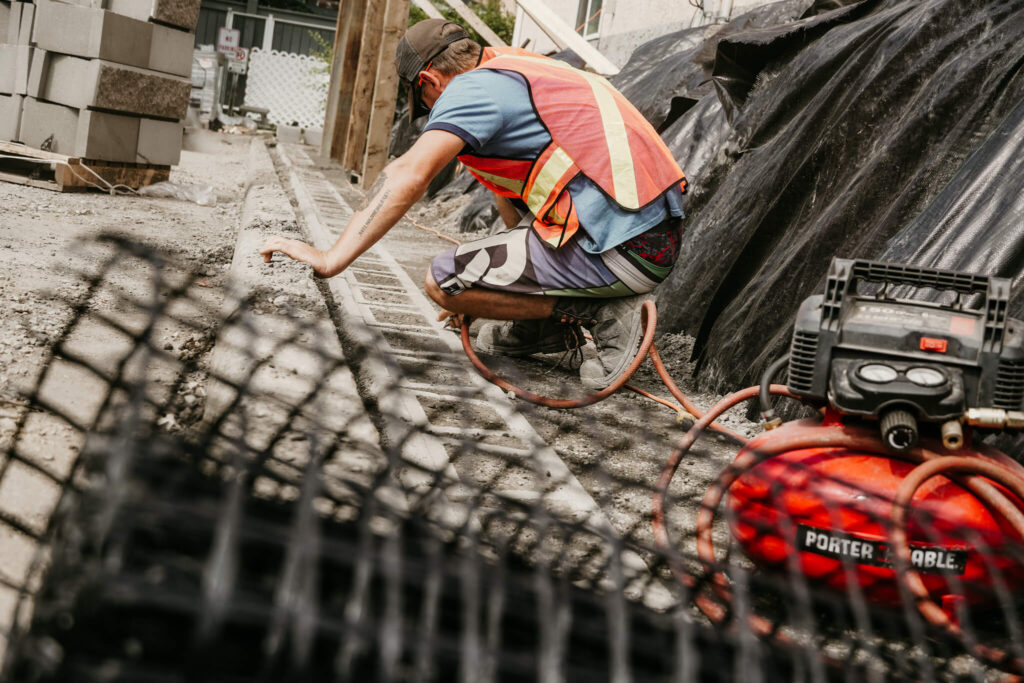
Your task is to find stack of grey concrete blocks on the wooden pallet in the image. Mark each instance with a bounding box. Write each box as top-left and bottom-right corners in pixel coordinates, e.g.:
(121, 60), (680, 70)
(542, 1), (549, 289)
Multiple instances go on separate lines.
(0, 0), (200, 165)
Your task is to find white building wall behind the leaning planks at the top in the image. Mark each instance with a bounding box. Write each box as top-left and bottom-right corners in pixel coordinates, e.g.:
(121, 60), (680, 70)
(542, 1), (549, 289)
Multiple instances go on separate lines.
(513, 0), (770, 67)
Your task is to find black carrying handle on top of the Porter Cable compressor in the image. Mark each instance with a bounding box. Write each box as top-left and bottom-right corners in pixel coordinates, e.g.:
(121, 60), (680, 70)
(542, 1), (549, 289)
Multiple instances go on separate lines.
(821, 258), (1010, 353)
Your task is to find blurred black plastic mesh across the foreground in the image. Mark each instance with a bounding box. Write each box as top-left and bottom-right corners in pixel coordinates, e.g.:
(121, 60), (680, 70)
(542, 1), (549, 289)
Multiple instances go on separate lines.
(0, 238), (1024, 682)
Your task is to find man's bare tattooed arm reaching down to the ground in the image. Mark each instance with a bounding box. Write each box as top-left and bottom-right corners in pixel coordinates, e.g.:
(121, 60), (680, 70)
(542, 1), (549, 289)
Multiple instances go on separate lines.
(260, 130), (465, 278)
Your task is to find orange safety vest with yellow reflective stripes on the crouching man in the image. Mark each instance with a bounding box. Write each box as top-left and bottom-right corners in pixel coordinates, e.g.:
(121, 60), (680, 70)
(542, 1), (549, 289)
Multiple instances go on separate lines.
(459, 47), (686, 248)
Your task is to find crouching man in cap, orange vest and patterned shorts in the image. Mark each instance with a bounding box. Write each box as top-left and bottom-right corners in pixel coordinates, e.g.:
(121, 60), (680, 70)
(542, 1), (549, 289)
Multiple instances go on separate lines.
(261, 19), (685, 389)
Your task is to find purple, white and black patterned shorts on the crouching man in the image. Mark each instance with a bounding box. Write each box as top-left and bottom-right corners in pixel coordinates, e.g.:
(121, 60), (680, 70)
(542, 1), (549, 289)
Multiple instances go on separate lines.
(430, 216), (682, 297)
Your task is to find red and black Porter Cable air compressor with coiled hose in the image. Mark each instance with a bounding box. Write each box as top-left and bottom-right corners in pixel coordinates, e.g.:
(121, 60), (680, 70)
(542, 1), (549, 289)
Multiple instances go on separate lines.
(724, 259), (1024, 621)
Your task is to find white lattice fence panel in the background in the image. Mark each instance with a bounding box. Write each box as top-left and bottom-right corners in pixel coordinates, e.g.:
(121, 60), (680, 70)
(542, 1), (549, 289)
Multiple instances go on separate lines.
(246, 47), (330, 128)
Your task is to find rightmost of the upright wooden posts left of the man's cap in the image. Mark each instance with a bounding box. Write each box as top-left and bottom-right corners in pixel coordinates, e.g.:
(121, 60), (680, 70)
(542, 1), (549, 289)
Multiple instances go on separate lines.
(362, 0), (409, 187)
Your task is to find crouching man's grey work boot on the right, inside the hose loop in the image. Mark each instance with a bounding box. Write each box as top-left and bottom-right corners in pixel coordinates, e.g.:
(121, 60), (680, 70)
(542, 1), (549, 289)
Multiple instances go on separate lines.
(556, 296), (645, 391)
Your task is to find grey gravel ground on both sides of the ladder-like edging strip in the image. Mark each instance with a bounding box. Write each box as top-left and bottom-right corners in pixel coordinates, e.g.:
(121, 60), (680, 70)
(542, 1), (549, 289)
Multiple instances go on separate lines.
(0, 132), (755, 659)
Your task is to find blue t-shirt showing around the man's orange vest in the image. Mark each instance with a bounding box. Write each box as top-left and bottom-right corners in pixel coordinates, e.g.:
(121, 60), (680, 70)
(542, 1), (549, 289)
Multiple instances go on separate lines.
(424, 69), (683, 254)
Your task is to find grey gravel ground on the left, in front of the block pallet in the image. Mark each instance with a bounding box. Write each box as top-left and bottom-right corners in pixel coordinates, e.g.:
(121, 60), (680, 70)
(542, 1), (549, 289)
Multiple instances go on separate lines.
(0, 126), (249, 654)
